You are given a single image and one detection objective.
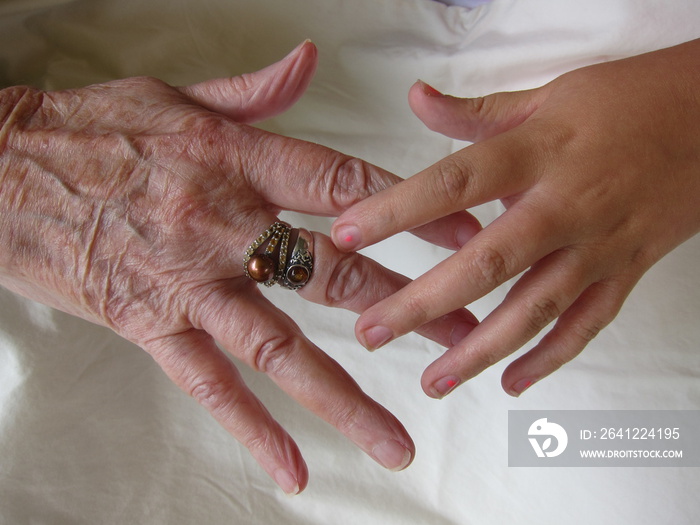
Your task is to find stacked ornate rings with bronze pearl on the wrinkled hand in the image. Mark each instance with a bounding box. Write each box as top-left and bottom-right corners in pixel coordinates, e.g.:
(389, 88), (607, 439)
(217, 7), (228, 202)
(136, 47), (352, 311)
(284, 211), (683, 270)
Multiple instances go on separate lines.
(243, 222), (314, 290)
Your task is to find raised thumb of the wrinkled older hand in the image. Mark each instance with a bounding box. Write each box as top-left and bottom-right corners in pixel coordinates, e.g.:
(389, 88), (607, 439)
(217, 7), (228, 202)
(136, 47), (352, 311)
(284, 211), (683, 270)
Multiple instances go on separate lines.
(179, 40), (318, 123)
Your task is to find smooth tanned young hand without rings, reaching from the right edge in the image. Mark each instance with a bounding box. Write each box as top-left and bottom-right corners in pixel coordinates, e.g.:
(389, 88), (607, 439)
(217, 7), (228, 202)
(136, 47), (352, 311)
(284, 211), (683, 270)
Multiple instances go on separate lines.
(332, 40), (700, 397)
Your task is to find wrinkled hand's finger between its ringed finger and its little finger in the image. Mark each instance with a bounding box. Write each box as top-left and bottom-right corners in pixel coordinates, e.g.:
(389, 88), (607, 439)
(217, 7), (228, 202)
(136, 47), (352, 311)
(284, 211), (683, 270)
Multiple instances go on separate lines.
(198, 283), (415, 470)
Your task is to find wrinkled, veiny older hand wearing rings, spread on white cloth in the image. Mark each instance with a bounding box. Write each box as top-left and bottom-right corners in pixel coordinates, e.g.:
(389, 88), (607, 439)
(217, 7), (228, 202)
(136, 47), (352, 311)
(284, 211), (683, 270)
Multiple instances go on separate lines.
(0, 42), (475, 493)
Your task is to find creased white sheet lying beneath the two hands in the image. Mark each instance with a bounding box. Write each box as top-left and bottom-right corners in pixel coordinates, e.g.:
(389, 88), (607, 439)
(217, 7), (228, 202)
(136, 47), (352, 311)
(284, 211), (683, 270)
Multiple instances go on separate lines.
(0, 0), (700, 525)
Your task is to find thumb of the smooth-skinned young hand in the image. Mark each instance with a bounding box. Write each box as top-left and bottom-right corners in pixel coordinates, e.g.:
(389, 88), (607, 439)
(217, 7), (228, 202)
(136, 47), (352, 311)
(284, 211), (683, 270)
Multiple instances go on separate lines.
(408, 80), (544, 142)
